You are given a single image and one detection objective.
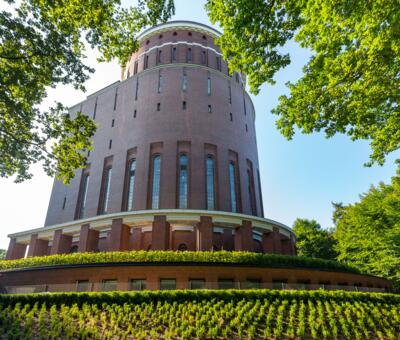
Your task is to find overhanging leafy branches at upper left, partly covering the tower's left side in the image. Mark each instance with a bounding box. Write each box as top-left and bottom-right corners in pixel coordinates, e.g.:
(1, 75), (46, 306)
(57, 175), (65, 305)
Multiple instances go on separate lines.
(0, 0), (174, 183)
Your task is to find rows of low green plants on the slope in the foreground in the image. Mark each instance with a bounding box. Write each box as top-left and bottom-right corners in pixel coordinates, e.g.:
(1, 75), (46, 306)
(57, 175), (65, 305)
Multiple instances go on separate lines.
(0, 290), (400, 340)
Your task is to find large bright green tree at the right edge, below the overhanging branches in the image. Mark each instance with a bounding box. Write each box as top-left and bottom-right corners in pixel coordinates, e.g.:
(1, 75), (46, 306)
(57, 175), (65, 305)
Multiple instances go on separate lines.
(334, 163), (400, 286)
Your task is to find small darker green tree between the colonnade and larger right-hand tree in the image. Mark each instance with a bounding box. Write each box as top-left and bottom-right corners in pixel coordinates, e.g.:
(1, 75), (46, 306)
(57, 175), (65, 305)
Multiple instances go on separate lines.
(293, 218), (337, 259)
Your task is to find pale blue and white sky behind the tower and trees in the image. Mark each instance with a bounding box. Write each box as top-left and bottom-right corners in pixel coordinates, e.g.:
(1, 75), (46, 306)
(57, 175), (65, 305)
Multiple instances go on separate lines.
(0, 0), (400, 248)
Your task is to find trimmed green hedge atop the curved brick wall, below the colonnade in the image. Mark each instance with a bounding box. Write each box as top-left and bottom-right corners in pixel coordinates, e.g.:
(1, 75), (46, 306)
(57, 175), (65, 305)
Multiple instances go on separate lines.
(0, 250), (360, 273)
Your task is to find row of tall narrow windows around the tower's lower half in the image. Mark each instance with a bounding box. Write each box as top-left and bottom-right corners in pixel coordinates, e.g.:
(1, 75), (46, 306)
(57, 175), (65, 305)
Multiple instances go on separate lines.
(74, 153), (261, 218)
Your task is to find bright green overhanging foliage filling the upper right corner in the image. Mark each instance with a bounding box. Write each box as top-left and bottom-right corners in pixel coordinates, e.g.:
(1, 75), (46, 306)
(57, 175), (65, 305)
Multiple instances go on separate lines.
(206, 0), (400, 165)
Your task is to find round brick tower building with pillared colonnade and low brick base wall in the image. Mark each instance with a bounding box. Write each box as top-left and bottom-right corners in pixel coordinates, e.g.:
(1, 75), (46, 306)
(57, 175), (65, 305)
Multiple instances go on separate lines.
(2, 21), (390, 289)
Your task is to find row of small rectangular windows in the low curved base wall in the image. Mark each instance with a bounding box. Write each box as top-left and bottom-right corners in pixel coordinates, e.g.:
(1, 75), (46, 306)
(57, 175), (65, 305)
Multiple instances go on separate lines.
(76, 278), (373, 292)
